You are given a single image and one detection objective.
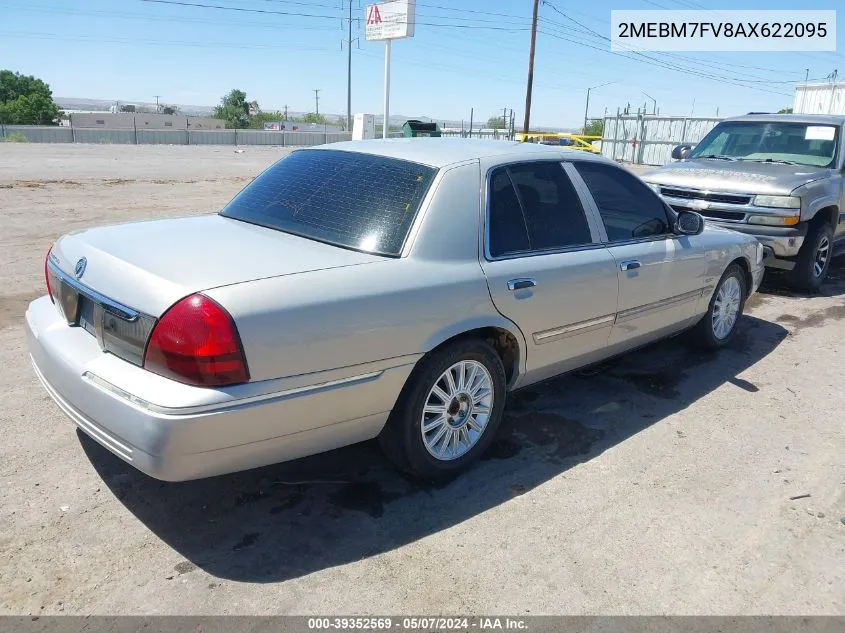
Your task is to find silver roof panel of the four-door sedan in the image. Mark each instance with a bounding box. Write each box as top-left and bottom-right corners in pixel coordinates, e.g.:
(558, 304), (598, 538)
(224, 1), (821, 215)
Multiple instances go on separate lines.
(309, 137), (607, 167)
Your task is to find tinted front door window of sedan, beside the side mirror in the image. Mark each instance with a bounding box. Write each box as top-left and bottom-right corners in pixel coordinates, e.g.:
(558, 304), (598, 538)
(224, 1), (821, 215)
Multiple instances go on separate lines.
(573, 161), (670, 242)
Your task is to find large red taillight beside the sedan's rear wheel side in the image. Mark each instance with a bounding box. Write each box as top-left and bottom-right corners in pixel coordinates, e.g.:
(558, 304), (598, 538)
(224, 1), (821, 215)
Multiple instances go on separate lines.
(144, 294), (249, 386)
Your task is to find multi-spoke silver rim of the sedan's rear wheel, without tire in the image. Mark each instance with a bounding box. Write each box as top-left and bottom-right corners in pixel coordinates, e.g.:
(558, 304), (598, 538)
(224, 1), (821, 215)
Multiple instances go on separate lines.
(420, 360), (493, 461)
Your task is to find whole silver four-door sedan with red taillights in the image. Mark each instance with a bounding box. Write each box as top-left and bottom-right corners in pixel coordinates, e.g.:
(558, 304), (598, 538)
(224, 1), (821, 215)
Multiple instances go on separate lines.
(26, 139), (763, 481)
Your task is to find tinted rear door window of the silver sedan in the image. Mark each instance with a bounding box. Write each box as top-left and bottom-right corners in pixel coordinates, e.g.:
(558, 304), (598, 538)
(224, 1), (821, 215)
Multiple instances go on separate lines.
(488, 161), (593, 258)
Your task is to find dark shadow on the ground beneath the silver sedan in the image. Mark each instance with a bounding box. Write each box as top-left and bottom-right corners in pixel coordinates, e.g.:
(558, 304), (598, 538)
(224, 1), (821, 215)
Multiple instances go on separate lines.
(80, 316), (787, 582)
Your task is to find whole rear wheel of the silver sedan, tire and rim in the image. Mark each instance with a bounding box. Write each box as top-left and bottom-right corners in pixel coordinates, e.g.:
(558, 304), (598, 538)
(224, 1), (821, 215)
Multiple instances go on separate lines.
(379, 339), (506, 479)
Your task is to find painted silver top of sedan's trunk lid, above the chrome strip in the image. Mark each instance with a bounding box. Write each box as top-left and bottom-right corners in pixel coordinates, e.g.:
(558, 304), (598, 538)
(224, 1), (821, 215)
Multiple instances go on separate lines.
(51, 215), (383, 317)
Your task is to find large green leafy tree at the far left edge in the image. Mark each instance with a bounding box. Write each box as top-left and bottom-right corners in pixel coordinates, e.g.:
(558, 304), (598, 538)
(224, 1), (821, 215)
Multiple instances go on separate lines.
(0, 70), (62, 125)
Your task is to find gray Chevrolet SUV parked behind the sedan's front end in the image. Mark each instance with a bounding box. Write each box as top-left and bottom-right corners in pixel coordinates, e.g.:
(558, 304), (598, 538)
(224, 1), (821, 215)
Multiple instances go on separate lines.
(643, 114), (845, 291)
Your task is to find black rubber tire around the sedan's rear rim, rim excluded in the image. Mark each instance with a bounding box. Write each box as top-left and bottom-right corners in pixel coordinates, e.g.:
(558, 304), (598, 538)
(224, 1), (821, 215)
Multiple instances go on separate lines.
(379, 338), (507, 481)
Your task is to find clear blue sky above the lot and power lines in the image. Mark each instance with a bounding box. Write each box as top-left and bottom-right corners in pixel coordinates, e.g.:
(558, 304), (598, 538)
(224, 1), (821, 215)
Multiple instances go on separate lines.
(0, 0), (845, 127)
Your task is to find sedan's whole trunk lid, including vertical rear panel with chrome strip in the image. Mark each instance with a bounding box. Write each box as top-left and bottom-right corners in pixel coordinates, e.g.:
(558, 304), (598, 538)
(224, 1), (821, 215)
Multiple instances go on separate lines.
(42, 215), (382, 365)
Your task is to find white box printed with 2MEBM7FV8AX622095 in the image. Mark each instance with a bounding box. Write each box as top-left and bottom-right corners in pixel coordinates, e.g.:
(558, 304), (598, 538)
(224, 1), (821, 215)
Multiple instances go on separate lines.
(610, 9), (836, 52)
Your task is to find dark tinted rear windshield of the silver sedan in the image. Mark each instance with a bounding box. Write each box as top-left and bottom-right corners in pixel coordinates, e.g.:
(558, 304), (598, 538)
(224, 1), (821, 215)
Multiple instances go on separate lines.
(221, 149), (436, 256)
